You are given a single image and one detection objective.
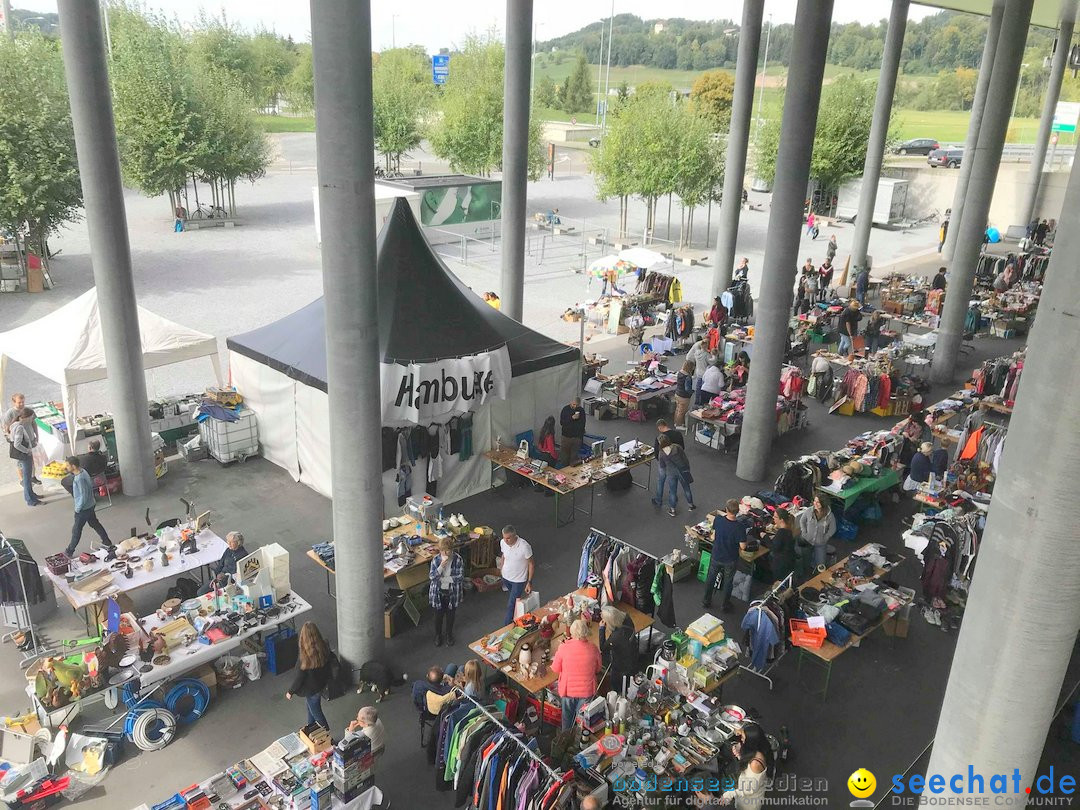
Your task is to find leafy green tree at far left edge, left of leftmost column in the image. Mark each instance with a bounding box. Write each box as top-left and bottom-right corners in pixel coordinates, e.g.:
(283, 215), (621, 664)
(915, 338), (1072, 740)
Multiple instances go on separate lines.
(0, 33), (82, 267)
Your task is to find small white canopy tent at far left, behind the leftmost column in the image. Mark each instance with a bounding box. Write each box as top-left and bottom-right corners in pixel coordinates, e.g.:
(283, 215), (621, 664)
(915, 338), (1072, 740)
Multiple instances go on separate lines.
(0, 287), (221, 453)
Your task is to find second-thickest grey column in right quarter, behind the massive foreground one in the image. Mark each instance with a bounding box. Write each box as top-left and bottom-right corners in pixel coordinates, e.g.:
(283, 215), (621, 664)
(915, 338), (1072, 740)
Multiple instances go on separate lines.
(931, 0), (1034, 382)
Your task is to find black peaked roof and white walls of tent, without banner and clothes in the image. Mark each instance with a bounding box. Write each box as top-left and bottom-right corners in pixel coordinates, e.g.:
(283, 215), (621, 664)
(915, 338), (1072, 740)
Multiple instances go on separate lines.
(227, 199), (580, 513)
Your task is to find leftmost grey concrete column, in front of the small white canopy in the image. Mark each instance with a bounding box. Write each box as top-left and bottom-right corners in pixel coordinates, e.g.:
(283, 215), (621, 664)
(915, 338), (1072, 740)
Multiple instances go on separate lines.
(59, 0), (158, 496)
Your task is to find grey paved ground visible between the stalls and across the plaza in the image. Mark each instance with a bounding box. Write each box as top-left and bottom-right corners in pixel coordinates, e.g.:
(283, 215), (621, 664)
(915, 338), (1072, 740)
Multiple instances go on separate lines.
(6, 135), (1080, 810)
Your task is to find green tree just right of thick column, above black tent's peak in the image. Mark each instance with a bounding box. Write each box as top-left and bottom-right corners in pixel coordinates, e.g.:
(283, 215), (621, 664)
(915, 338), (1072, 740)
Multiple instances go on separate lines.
(372, 48), (432, 171)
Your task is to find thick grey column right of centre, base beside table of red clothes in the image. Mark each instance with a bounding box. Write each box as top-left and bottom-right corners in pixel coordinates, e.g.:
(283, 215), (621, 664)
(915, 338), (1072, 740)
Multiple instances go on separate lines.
(735, 0), (833, 481)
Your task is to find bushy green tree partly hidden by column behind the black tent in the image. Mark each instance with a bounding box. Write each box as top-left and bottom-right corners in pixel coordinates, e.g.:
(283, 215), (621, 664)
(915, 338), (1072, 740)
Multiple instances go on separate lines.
(430, 35), (544, 179)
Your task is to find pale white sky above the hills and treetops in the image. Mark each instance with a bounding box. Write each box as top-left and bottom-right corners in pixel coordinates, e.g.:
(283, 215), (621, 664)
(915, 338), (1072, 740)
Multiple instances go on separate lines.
(12, 0), (936, 53)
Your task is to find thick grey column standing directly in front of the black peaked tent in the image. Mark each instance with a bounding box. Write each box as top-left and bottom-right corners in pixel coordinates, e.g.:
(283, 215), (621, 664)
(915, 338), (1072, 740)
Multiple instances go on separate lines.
(311, 0), (384, 667)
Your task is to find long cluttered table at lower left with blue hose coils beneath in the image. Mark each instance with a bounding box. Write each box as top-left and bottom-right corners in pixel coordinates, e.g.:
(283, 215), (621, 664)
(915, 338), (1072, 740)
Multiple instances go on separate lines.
(0, 543), (311, 808)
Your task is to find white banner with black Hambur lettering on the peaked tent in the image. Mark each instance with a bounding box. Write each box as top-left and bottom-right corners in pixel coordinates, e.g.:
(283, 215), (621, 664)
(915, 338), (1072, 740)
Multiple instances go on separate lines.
(381, 346), (511, 427)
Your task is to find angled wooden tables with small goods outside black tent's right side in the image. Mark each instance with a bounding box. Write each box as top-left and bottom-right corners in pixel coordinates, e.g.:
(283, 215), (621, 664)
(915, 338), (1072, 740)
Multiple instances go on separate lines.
(484, 441), (653, 527)
